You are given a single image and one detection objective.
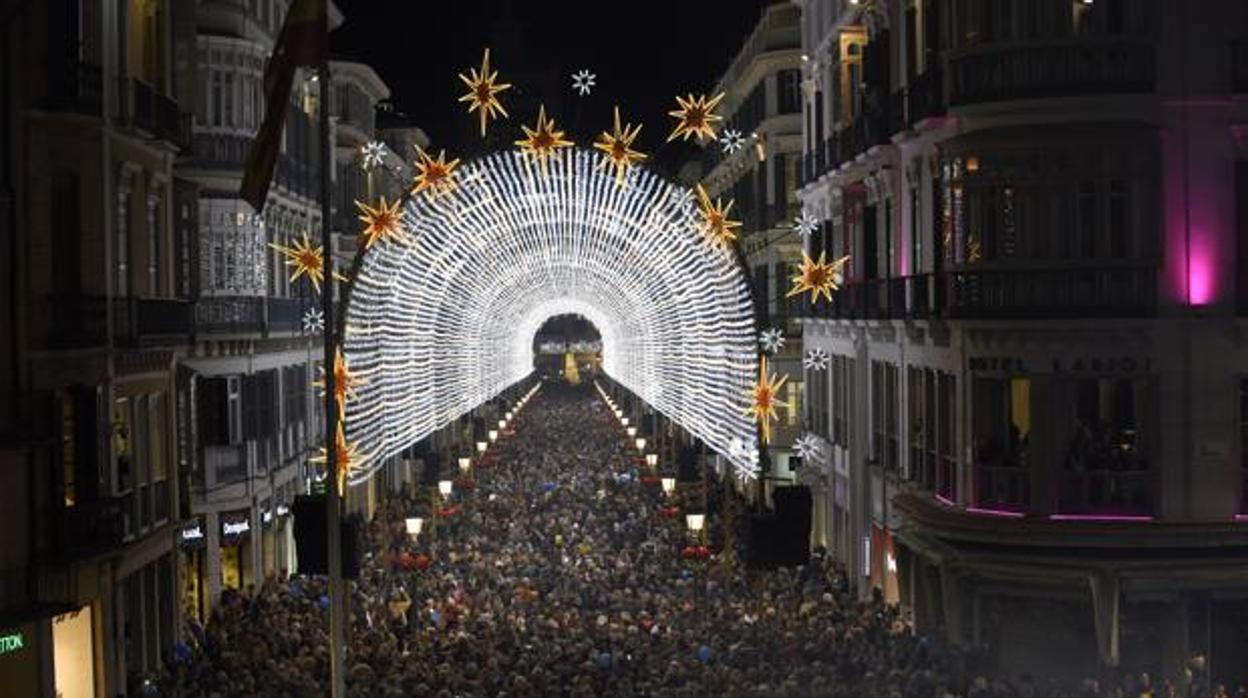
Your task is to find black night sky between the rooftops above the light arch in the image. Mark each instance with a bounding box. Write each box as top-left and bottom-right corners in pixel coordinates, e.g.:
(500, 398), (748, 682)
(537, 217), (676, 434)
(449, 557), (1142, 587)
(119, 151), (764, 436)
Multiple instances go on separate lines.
(332, 0), (771, 174)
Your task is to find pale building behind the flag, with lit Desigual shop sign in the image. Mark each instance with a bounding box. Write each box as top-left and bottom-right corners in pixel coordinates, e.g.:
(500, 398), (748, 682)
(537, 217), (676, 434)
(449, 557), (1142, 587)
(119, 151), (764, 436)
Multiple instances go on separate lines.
(170, 0), (342, 629)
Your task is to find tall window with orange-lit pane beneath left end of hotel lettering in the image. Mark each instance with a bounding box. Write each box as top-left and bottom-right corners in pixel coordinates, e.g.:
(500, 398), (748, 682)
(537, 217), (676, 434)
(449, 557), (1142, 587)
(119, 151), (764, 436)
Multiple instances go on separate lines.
(972, 377), (1031, 511)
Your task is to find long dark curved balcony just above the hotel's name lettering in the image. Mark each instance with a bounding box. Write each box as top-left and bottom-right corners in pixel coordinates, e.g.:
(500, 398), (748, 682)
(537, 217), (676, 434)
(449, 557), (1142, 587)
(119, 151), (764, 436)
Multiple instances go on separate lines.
(945, 267), (1157, 318)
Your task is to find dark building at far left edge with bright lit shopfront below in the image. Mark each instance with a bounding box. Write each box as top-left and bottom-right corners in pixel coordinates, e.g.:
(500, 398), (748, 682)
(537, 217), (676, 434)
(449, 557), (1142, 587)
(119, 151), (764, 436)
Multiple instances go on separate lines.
(0, 0), (191, 696)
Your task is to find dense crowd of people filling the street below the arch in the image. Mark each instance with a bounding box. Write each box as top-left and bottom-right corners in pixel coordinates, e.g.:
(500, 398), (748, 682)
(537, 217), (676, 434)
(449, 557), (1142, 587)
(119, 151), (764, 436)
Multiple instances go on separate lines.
(173, 385), (1243, 698)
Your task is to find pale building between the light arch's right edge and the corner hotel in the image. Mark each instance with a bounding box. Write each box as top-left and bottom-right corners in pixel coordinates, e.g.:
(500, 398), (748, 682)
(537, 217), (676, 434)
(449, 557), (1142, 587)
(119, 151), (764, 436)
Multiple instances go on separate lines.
(701, 4), (802, 501)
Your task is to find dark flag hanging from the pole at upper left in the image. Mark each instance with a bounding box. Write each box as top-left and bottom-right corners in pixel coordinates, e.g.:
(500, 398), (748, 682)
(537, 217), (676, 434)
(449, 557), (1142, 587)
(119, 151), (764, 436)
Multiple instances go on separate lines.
(238, 0), (329, 214)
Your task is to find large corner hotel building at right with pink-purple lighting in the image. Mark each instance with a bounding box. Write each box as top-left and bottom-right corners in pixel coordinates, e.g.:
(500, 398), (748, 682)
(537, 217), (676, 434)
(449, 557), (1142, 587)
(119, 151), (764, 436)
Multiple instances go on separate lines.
(796, 0), (1248, 683)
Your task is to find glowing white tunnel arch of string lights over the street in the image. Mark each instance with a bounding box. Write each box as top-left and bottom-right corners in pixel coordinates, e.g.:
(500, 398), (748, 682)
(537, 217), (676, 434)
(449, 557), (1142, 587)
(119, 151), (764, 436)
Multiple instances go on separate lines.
(343, 150), (758, 483)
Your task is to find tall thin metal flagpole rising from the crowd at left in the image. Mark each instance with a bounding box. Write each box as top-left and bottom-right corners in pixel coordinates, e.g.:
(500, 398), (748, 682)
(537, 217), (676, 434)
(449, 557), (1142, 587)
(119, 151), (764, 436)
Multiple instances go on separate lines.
(318, 61), (347, 698)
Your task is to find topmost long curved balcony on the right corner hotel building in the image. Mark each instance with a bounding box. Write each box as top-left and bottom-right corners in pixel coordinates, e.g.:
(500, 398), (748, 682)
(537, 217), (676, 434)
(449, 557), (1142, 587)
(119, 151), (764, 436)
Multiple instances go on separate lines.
(950, 39), (1156, 105)
